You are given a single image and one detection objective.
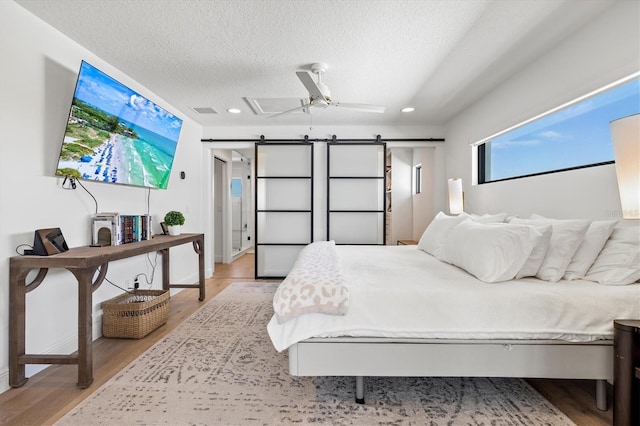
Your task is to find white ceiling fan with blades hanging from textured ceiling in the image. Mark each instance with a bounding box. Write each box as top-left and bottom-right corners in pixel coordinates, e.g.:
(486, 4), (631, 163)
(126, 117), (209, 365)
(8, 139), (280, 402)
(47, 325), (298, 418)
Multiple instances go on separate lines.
(268, 63), (385, 118)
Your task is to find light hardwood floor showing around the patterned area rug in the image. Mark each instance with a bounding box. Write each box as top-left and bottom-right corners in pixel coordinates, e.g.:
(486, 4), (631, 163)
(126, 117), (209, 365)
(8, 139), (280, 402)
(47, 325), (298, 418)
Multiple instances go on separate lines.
(0, 253), (612, 426)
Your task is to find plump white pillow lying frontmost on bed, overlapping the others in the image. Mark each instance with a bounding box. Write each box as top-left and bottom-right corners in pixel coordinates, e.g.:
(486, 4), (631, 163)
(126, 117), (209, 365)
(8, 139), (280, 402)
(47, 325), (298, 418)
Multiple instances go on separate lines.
(443, 219), (542, 283)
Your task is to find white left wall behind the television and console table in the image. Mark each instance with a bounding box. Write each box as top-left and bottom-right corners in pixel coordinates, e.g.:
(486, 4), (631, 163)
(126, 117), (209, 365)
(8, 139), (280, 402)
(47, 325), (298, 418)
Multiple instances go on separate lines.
(0, 1), (211, 392)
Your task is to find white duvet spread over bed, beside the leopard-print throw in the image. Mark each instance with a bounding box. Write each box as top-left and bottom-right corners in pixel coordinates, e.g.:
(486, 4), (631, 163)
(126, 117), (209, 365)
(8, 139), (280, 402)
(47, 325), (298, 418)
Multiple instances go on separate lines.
(267, 246), (640, 351)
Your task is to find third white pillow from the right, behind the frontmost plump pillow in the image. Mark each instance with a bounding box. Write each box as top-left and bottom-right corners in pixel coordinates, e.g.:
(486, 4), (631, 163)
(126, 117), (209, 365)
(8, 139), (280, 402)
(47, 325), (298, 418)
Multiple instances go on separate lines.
(510, 218), (590, 282)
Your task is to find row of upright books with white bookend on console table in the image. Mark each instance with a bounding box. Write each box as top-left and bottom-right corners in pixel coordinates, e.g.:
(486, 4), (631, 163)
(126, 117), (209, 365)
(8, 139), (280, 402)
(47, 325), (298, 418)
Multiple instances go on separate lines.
(91, 213), (152, 246)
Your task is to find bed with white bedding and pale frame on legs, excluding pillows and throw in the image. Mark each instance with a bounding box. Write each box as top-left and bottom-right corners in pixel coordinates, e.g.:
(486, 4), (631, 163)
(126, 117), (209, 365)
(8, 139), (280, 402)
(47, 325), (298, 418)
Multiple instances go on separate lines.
(267, 216), (640, 410)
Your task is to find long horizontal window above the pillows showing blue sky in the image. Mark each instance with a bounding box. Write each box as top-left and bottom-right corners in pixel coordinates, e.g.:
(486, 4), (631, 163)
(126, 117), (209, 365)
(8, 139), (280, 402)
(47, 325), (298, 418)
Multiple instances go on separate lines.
(477, 75), (640, 183)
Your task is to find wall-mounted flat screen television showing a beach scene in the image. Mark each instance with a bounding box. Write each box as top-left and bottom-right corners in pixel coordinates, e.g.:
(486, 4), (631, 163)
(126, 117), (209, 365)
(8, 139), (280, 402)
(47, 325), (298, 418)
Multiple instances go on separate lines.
(56, 61), (182, 189)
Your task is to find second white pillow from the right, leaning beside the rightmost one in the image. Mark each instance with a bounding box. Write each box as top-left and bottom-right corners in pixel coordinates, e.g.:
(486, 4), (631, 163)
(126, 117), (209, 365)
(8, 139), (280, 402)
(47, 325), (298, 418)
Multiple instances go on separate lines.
(563, 220), (617, 280)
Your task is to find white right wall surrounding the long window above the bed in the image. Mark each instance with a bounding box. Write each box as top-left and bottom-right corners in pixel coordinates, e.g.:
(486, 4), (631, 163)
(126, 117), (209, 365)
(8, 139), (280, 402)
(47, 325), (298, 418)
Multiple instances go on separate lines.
(446, 1), (640, 219)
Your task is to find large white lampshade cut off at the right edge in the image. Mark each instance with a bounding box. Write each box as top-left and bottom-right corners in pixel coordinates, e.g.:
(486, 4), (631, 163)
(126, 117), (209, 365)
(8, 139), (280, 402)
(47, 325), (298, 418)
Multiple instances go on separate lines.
(610, 114), (640, 219)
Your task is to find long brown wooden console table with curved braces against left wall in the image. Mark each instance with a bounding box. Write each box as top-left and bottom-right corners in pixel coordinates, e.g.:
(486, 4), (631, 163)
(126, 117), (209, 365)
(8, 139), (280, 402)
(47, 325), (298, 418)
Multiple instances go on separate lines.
(9, 234), (205, 388)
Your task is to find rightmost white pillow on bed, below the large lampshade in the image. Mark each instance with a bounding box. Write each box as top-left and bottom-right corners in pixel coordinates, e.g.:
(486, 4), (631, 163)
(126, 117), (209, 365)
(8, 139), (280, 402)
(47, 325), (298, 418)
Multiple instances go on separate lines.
(584, 224), (640, 285)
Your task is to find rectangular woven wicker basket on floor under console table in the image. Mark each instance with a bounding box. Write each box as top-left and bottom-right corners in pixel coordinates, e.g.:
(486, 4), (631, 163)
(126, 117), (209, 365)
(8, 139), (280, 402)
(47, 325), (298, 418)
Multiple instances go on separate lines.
(102, 290), (169, 339)
